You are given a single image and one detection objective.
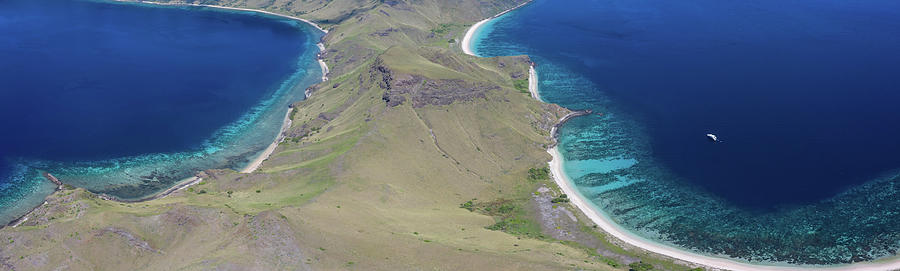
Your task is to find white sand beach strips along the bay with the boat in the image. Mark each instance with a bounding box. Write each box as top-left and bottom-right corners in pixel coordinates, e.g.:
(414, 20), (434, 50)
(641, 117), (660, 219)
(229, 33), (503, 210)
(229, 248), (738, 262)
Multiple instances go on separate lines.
(468, 1), (900, 271)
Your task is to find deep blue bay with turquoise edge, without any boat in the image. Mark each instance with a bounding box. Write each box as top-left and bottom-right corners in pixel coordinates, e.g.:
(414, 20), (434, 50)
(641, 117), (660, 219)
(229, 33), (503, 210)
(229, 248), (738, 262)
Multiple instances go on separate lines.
(0, 0), (322, 223)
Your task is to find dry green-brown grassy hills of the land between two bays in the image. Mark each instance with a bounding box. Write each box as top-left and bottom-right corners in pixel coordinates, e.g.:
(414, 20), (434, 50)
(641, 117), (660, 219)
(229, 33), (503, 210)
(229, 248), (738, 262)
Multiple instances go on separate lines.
(0, 0), (696, 270)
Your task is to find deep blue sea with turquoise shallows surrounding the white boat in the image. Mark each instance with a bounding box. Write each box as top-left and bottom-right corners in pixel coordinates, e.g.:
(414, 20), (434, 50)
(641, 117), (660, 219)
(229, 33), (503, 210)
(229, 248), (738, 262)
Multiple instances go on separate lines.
(474, 0), (900, 264)
